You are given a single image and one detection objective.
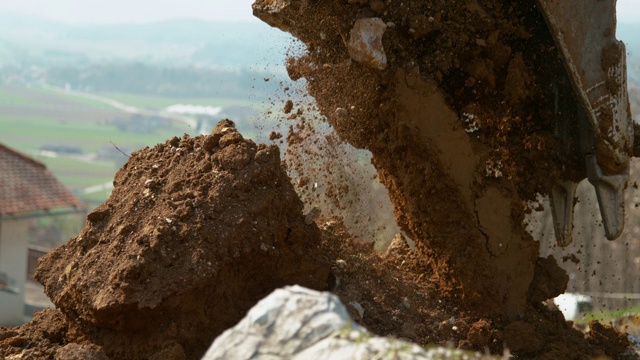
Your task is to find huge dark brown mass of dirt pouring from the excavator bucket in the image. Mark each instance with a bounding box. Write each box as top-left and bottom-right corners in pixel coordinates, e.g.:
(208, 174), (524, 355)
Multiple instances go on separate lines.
(253, 0), (636, 358)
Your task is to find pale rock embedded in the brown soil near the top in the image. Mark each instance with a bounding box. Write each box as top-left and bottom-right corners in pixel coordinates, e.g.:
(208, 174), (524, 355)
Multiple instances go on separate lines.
(349, 18), (387, 70)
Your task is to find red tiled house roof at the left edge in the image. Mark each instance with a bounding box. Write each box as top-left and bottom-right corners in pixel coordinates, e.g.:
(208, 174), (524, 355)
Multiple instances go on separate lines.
(0, 144), (82, 216)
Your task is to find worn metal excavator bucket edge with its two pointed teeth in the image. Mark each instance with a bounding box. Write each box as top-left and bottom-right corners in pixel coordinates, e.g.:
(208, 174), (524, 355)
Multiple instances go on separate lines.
(537, 0), (633, 246)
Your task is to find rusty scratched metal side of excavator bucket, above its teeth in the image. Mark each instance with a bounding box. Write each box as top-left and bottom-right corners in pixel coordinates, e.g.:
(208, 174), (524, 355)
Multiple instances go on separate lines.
(537, 0), (633, 175)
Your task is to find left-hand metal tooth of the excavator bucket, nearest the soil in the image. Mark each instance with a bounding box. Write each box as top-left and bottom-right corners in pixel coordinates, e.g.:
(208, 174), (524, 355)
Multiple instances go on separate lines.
(551, 181), (578, 247)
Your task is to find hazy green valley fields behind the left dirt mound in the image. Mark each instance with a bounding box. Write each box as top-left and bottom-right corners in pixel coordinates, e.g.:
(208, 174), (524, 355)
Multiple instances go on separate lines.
(0, 85), (215, 207)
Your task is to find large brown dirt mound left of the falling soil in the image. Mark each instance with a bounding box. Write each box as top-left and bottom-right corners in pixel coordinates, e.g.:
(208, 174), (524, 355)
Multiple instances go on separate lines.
(3, 120), (329, 359)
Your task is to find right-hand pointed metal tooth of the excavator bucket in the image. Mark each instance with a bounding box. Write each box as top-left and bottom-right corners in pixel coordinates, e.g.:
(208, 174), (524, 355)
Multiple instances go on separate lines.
(585, 155), (629, 240)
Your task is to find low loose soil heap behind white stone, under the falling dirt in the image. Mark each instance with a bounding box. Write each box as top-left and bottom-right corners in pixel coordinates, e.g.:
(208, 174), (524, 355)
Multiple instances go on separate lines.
(319, 219), (637, 360)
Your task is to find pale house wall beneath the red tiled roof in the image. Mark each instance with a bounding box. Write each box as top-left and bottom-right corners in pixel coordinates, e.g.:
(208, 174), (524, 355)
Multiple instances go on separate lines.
(0, 219), (29, 326)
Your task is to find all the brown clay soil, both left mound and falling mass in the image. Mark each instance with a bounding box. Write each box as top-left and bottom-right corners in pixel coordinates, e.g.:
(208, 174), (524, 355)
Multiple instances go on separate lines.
(0, 0), (629, 359)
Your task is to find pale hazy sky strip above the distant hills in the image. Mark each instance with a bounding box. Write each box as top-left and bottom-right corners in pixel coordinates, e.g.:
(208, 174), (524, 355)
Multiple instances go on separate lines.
(0, 0), (640, 23)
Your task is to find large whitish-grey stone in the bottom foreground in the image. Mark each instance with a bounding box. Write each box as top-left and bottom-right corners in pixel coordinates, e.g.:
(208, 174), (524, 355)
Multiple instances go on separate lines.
(202, 286), (495, 360)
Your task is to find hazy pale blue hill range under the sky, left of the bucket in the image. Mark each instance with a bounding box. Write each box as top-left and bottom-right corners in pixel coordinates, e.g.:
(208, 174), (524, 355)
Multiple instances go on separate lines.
(0, 14), (292, 68)
